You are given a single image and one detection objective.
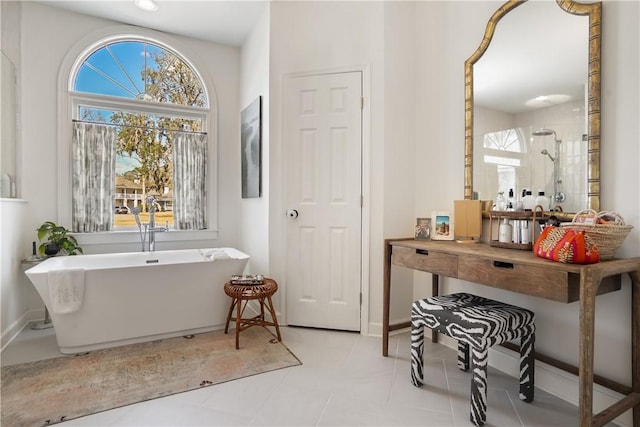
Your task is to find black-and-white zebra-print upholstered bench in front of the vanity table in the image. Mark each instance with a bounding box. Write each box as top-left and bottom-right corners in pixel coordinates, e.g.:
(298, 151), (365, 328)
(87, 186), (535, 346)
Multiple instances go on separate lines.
(411, 293), (535, 426)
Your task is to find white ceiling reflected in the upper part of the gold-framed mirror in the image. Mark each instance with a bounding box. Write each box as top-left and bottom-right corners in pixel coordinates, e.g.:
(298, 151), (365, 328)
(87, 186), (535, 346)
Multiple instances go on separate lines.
(473, 1), (589, 113)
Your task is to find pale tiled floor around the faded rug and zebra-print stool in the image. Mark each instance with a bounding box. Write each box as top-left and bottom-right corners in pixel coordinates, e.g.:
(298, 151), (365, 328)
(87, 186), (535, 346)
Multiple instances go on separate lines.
(2, 327), (592, 427)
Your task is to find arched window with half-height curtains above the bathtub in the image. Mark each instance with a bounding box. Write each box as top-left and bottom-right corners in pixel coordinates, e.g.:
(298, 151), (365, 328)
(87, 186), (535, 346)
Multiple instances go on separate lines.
(69, 37), (209, 232)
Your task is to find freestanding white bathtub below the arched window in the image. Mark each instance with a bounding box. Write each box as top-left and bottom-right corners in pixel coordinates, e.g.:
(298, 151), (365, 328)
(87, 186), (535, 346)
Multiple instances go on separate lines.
(26, 248), (249, 354)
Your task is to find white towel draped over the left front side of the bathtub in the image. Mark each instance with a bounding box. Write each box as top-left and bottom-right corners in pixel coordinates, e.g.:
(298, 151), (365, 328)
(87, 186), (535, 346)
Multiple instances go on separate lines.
(47, 268), (85, 314)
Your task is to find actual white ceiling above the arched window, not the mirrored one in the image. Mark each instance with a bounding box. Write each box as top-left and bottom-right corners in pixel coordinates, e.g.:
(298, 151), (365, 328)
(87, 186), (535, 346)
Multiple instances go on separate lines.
(35, 0), (268, 46)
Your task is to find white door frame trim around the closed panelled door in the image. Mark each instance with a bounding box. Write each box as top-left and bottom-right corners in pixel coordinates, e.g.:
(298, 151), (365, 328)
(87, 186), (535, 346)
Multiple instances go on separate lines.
(280, 65), (371, 335)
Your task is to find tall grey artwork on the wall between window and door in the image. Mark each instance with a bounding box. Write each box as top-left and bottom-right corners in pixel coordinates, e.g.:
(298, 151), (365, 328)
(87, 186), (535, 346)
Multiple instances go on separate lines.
(240, 96), (262, 199)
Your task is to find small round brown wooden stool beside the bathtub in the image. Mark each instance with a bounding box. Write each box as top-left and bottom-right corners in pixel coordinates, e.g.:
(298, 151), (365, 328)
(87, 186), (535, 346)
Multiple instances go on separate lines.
(224, 278), (282, 350)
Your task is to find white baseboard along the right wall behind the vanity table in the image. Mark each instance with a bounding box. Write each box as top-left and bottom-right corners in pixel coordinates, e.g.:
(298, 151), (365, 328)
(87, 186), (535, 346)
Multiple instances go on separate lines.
(369, 323), (633, 427)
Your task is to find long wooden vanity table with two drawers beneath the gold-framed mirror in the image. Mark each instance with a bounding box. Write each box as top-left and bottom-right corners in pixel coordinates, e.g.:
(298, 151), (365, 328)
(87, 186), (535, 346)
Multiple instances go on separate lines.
(382, 239), (640, 427)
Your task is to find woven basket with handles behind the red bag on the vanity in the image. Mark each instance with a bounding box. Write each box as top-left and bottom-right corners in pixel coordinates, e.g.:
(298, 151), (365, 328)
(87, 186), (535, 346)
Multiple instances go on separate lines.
(560, 209), (633, 260)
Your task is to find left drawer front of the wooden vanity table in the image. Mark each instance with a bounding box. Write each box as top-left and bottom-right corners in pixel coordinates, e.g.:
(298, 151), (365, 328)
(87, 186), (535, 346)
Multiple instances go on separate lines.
(391, 246), (458, 278)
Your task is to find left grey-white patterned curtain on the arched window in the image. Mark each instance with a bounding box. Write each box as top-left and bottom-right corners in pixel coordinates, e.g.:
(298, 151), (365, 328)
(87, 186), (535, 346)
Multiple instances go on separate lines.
(72, 122), (116, 233)
